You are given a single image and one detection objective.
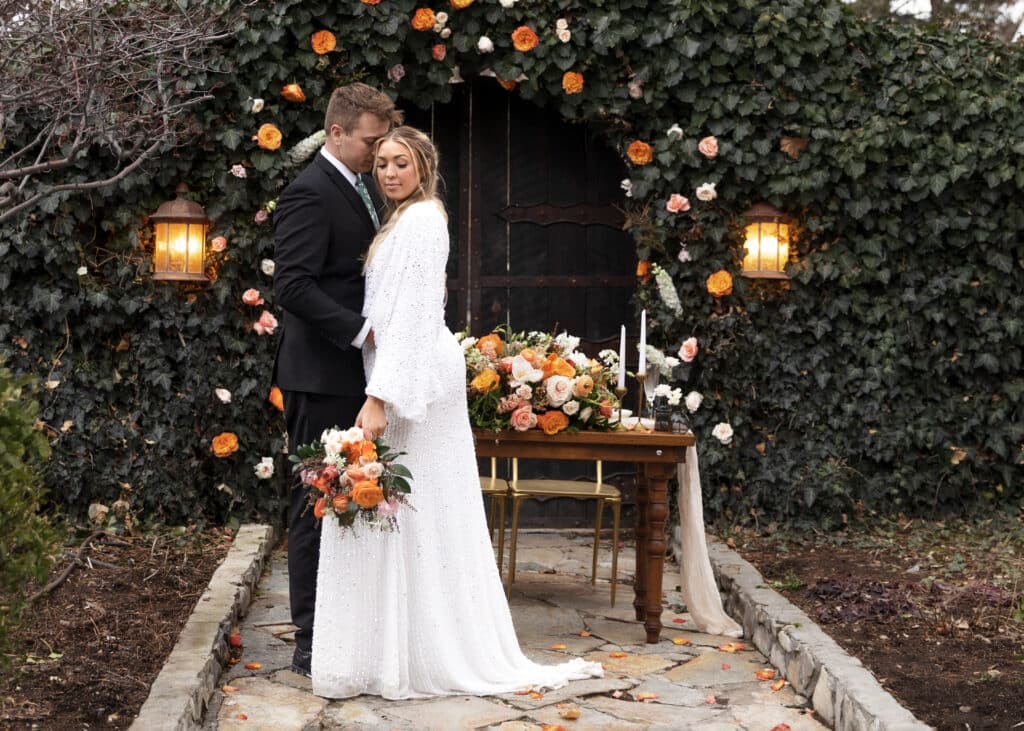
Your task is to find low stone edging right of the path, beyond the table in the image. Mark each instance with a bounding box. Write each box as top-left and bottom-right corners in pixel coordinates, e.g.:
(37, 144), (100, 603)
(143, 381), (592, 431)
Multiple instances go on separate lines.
(708, 541), (931, 731)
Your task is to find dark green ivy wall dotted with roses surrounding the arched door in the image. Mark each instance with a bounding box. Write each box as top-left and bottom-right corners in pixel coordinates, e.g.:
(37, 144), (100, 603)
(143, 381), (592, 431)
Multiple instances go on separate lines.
(0, 0), (1024, 524)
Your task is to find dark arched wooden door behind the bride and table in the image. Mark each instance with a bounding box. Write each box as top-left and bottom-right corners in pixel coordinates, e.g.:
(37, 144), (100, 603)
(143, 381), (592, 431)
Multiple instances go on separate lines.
(406, 78), (636, 525)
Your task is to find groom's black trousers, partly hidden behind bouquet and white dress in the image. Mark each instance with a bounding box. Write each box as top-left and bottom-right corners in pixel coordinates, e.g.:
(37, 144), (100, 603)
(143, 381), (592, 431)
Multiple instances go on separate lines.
(284, 391), (366, 652)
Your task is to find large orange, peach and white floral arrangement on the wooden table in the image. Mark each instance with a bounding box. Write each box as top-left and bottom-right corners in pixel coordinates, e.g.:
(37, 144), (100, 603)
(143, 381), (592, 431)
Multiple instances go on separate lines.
(460, 329), (617, 434)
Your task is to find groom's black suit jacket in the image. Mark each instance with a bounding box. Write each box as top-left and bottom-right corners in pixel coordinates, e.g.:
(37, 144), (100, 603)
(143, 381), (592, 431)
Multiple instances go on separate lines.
(273, 153), (380, 395)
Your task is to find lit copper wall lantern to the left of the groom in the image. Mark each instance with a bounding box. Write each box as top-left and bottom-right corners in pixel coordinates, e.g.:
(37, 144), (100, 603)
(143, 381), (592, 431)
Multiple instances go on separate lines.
(150, 183), (210, 282)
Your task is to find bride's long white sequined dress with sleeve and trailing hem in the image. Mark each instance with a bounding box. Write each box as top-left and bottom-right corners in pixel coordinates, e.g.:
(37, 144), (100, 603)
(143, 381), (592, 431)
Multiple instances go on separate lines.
(312, 197), (602, 699)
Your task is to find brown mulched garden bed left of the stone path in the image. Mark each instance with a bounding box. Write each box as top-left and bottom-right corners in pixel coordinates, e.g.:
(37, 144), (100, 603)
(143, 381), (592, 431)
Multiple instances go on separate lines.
(0, 530), (230, 729)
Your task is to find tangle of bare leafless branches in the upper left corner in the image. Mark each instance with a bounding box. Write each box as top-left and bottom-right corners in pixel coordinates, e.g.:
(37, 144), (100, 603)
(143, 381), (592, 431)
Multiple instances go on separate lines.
(0, 0), (227, 221)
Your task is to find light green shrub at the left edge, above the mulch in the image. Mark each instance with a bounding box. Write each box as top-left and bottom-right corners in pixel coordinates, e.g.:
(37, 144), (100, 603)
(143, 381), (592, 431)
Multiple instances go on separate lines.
(0, 367), (57, 664)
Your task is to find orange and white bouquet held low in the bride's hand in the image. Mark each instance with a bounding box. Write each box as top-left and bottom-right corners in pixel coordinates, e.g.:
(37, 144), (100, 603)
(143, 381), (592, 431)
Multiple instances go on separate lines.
(288, 427), (413, 530)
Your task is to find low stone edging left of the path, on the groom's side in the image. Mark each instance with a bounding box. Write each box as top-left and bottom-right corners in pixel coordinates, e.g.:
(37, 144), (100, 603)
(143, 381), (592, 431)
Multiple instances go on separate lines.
(131, 524), (278, 731)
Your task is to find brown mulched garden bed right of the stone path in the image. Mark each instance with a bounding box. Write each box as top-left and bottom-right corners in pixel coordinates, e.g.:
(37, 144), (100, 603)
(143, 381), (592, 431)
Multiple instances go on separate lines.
(728, 517), (1024, 730)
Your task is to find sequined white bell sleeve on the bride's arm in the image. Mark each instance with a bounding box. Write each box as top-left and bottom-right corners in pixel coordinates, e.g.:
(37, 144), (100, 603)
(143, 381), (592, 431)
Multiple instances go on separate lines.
(364, 202), (449, 422)
